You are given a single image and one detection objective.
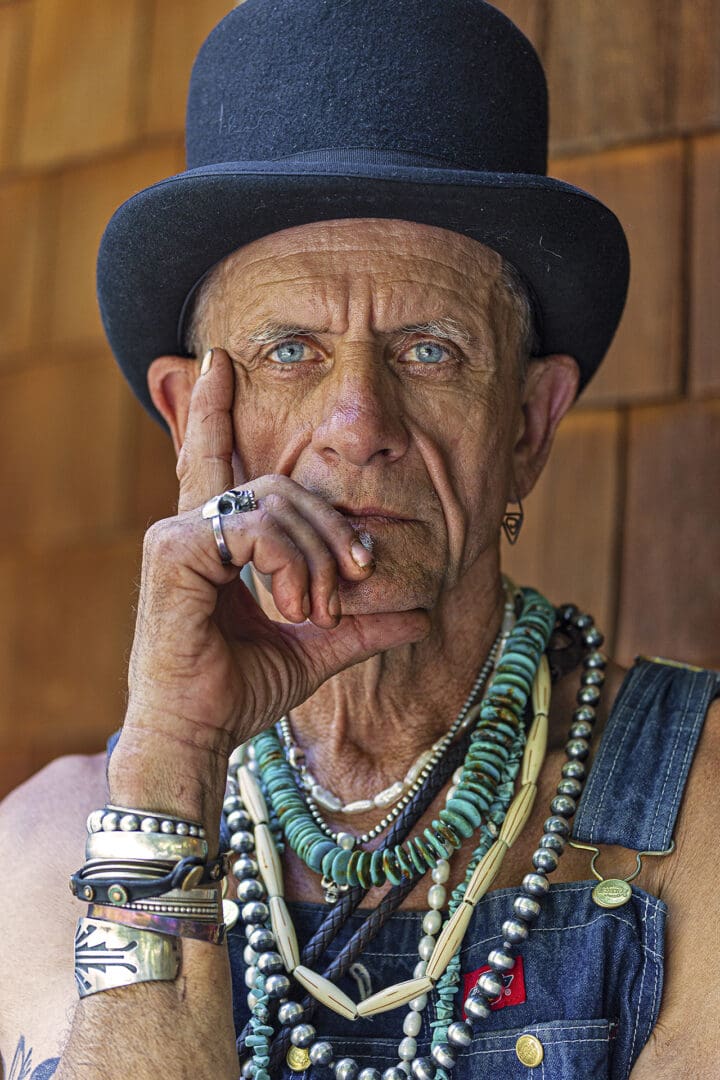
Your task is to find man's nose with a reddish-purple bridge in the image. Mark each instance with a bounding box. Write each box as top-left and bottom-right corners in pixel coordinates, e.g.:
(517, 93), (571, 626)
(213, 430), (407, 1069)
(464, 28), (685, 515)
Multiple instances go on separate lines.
(313, 350), (408, 467)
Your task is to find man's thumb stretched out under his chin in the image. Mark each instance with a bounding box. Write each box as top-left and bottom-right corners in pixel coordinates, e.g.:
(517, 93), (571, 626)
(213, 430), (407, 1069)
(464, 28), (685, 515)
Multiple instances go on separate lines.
(284, 609), (430, 692)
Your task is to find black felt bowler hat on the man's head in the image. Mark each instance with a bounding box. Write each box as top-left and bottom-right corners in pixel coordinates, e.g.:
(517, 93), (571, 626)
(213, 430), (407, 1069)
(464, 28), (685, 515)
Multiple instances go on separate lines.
(97, 0), (628, 419)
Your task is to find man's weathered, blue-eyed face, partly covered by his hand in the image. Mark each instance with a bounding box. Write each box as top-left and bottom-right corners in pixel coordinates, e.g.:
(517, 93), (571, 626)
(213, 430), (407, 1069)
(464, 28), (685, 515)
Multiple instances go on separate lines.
(194, 219), (521, 612)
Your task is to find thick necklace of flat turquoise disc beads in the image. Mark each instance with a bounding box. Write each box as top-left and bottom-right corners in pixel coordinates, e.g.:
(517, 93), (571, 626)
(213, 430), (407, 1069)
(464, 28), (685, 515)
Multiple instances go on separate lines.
(253, 589), (555, 889)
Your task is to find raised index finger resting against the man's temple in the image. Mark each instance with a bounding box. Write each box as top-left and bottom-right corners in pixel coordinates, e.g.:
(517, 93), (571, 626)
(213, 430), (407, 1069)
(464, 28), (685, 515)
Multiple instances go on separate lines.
(177, 348), (235, 512)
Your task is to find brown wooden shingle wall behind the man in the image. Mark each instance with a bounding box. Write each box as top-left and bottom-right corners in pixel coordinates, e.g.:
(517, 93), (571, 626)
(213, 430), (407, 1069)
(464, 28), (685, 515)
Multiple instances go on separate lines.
(0, 0), (720, 795)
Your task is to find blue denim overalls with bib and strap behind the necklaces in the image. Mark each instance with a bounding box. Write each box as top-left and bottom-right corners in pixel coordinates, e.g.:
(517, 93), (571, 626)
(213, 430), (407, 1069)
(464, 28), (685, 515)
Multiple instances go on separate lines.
(110, 659), (720, 1080)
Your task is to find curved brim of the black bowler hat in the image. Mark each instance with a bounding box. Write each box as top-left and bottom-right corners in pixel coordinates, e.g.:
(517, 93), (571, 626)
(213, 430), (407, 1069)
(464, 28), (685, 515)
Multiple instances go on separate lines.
(97, 160), (629, 423)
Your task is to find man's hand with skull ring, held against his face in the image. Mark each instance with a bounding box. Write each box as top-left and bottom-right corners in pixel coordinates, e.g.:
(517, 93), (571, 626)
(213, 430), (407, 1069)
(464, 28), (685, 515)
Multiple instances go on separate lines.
(126, 349), (427, 746)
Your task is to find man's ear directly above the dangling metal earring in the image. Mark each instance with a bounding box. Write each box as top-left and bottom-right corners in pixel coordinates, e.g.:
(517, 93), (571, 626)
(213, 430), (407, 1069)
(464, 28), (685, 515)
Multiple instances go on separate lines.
(513, 353), (580, 499)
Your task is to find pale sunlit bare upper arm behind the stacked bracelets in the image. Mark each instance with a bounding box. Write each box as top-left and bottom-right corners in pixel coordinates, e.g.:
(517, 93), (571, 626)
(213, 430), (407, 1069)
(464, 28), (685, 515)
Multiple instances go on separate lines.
(0, 754), (107, 1080)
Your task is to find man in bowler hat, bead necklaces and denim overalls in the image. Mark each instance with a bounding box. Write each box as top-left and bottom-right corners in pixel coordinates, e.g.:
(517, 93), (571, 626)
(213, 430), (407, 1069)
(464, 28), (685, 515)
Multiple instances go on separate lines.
(0, 0), (720, 1080)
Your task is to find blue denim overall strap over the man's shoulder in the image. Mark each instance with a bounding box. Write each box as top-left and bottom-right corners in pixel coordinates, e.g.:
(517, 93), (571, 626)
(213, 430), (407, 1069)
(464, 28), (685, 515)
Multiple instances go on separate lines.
(573, 658), (720, 851)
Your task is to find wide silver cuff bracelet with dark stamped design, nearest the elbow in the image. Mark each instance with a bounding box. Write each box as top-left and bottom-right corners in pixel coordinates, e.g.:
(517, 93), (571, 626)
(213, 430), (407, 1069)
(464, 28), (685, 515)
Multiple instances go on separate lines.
(74, 918), (180, 998)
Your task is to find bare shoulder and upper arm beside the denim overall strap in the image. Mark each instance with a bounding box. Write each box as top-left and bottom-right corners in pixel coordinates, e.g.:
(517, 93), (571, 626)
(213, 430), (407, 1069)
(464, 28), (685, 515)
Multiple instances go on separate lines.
(633, 686), (720, 1080)
